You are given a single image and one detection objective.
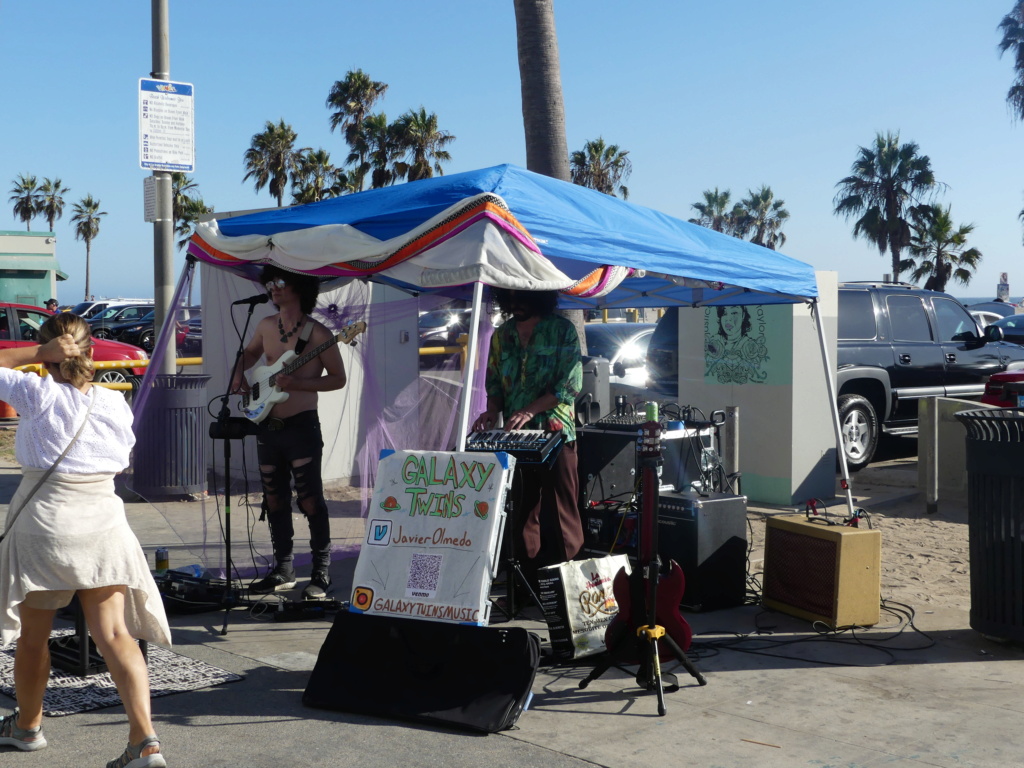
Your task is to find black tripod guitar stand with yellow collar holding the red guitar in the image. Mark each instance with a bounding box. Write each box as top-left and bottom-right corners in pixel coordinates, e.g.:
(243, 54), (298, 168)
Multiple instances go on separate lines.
(580, 412), (708, 717)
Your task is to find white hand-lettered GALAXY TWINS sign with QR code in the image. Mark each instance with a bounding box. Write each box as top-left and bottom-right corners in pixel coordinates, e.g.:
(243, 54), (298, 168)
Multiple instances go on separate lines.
(350, 451), (515, 625)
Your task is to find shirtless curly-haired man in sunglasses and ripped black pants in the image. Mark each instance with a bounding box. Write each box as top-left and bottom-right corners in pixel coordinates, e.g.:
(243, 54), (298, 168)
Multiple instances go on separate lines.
(231, 265), (345, 600)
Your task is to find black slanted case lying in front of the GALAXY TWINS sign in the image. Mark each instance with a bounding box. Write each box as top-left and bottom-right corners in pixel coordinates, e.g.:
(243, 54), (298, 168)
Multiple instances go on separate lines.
(302, 611), (541, 733)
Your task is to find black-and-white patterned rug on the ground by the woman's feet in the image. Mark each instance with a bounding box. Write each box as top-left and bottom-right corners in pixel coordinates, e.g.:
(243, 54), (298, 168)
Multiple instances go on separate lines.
(0, 629), (243, 717)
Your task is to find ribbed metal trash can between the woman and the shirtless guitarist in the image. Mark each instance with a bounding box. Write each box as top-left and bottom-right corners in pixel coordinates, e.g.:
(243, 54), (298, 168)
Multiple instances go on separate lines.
(132, 374), (210, 501)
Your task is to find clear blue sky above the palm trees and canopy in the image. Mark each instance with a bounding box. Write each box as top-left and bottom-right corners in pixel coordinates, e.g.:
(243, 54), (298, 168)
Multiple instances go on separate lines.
(0, 0), (1024, 303)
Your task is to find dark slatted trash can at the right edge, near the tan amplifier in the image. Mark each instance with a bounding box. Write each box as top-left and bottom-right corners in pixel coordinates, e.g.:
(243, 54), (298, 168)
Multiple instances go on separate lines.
(956, 409), (1024, 641)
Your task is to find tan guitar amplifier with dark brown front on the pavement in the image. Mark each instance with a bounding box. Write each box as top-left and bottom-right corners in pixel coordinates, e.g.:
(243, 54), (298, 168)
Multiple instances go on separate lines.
(761, 515), (882, 629)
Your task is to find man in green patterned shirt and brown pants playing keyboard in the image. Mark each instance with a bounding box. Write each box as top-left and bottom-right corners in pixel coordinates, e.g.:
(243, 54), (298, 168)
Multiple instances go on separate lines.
(473, 288), (583, 590)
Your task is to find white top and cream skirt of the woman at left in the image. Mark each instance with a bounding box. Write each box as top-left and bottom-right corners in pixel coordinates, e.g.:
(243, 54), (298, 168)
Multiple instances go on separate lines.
(0, 369), (171, 645)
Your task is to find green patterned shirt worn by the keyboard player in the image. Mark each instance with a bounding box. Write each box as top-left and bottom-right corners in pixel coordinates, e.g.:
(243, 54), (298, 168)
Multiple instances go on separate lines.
(486, 314), (583, 442)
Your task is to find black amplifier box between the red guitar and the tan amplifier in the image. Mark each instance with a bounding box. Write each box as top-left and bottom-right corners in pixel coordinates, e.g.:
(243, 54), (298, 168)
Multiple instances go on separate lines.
(657, 492), (746, 610)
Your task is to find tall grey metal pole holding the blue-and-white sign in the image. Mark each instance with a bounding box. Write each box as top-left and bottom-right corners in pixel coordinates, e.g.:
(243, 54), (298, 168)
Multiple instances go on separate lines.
(150, 0), (175, 374)
